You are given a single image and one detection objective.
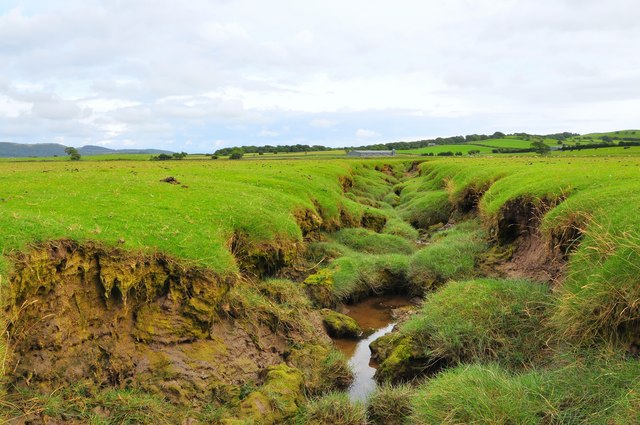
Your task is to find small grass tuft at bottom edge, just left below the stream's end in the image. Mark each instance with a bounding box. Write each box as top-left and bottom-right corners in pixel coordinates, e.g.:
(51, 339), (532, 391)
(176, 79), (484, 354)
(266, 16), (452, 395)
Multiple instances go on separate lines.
(299, 392), (367, 425)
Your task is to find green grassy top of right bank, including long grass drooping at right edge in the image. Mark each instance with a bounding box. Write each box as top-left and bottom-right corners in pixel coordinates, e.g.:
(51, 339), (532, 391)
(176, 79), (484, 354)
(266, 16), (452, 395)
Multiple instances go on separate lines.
(412, 157), (640, 348)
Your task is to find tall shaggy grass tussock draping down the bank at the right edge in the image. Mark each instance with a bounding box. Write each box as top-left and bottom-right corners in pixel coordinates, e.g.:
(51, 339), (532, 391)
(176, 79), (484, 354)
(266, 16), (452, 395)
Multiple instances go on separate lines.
(553, 223), (640, 348)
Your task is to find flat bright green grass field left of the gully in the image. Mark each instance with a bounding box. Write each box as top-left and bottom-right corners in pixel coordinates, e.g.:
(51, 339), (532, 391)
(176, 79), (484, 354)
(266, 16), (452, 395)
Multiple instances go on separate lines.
(0, 160), (370, 272)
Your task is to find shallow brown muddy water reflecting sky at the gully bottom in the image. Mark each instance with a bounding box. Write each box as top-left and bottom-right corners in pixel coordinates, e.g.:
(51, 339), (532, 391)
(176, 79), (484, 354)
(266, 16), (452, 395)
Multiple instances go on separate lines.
(334, 295), (411, 400)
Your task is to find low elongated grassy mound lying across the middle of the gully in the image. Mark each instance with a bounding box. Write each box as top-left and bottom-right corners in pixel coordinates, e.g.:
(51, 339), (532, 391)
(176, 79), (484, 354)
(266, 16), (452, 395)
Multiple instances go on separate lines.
(331, 229), (415, 254)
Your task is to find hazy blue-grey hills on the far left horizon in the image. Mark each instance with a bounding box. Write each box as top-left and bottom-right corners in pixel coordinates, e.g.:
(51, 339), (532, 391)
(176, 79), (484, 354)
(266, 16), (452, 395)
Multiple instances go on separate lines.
(0, 142), (173, 158)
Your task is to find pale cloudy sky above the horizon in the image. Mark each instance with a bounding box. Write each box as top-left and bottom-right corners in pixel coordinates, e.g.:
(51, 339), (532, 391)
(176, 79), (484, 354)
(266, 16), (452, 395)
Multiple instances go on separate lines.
(0, 0), (640, 153)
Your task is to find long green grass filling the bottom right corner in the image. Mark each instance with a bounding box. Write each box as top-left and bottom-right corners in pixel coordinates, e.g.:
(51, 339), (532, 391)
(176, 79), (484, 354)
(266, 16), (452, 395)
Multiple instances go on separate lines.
(408, 352), (640, 425)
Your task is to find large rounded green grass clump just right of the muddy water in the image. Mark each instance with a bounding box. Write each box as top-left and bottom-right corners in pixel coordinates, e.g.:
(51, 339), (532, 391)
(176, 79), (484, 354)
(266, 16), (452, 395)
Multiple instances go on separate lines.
(402, 279), (550, 368)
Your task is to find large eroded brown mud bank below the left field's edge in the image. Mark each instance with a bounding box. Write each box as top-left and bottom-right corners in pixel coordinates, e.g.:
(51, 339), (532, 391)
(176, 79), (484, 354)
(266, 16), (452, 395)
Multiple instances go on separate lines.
(8, 240), (328, 404)
